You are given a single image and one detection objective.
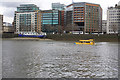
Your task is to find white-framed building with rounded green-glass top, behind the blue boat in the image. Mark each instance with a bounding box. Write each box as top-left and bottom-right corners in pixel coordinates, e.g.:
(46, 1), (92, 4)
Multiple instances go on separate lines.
(14, 4), (41, 34)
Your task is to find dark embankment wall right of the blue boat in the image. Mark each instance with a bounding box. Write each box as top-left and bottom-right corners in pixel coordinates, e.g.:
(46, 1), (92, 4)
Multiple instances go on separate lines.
(46, 34), (120, 42)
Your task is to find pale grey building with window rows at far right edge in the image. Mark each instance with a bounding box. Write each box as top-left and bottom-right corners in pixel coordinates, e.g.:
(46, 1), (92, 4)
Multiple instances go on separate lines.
(107, 2), (120, 34)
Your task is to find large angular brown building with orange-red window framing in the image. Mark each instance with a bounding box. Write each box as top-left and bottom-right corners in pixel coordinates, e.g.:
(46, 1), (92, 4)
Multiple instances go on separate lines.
(66, 2), (102, 33)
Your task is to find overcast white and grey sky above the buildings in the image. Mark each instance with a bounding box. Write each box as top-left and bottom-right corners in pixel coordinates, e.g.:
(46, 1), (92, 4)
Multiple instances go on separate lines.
(0, 0), (120, 23)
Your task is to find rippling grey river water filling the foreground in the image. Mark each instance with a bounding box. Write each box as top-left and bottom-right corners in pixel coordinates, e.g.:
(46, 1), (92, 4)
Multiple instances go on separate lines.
(2, 40), (118, 78)
